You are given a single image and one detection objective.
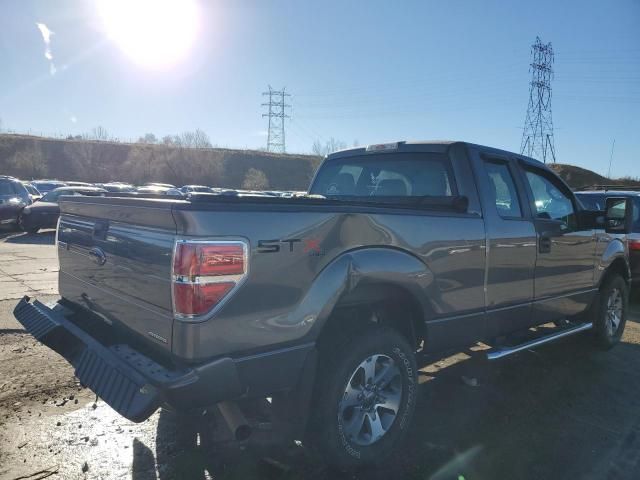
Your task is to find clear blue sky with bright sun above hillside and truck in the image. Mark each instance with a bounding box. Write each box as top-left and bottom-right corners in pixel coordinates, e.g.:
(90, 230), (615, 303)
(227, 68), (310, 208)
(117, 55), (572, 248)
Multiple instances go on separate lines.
(0, 0), (640, 176)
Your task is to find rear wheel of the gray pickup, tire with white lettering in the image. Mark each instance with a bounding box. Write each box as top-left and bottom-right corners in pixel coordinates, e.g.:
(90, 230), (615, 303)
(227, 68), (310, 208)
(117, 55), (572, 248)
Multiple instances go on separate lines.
(310, 325), (418, 470)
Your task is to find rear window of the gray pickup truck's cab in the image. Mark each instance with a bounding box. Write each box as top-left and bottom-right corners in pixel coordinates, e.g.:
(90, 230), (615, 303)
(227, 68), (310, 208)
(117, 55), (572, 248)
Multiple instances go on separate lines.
(310, 153), (455, 201)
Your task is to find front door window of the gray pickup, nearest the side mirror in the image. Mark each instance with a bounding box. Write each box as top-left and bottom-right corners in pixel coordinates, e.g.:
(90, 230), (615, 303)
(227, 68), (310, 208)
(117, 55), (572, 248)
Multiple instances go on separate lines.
(526, 170), (577, 229)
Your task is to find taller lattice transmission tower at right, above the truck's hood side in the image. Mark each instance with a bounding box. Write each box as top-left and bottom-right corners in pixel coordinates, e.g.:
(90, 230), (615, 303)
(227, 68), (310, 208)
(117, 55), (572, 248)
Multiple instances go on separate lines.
(520, 37), (556, 163)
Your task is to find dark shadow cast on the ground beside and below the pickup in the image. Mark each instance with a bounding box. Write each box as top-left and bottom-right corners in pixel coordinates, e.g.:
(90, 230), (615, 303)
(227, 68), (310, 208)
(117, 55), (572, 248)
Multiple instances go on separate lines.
(127, 326), (640, 480)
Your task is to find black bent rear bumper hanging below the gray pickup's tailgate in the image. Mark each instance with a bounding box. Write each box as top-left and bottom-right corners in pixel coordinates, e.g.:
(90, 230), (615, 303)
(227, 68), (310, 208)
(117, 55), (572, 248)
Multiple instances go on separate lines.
(14, 297), (260, 422)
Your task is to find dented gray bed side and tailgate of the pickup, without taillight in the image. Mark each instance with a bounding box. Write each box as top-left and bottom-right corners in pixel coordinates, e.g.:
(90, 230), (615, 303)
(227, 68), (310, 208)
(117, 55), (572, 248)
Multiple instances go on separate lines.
(57, 194), (485, 361)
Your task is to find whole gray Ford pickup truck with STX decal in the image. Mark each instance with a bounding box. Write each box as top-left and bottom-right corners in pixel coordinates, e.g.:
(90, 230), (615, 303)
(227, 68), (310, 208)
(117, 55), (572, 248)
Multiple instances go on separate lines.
(15, 142), (632, 468)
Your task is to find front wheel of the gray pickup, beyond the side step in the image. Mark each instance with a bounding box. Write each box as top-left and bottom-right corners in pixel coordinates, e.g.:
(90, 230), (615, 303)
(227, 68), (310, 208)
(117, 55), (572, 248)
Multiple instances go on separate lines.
(593, 274), (629, 350)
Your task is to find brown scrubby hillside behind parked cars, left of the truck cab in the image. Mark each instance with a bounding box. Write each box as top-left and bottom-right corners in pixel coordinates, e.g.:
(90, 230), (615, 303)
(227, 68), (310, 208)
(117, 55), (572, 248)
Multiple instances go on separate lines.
(0, 134), (321, 190)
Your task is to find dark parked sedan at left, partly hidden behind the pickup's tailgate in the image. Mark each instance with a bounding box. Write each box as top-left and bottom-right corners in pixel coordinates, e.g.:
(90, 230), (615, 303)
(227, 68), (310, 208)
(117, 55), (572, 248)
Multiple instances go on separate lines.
(18, 187), (106, 233)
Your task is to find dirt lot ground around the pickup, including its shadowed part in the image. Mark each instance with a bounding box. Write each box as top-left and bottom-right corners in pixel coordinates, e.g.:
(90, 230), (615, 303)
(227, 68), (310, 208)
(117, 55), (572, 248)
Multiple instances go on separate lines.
(0, 228), (640, 480)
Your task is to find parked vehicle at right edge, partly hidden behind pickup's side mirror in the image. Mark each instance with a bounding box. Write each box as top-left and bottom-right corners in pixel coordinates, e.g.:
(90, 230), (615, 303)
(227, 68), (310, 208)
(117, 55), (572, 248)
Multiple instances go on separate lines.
(576, 185), (640, 284)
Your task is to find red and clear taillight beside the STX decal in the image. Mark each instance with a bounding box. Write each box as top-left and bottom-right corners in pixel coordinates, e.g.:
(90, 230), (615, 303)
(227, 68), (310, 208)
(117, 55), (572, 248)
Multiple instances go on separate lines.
(172, 240), (248, 319)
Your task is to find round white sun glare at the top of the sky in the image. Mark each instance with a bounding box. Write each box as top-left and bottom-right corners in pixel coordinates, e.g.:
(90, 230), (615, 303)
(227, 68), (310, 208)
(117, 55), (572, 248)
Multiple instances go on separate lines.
(98, 0), (199, 68)
